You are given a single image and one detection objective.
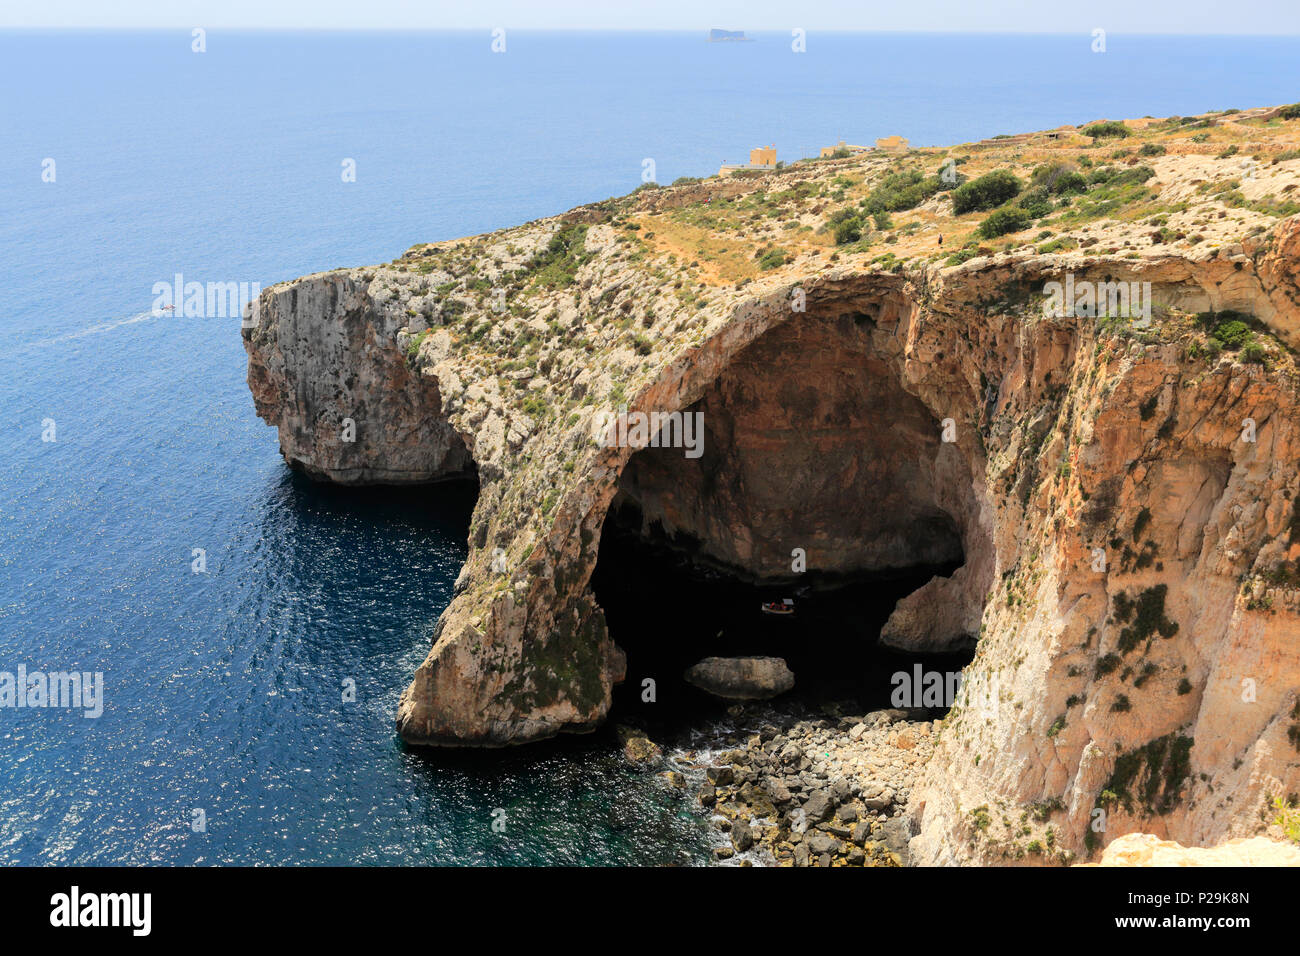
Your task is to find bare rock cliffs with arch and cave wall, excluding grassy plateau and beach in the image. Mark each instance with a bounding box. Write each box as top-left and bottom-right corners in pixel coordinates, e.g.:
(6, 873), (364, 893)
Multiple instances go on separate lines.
(244, 110), (1300, 862)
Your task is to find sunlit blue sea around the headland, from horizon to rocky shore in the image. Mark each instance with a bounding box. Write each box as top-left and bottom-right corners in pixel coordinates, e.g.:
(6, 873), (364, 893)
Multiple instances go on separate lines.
(0, 31), (1300, 864)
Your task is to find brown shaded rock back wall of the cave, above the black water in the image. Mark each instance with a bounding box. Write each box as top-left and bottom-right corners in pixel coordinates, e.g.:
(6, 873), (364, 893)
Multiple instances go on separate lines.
(619, 302), (971, 580)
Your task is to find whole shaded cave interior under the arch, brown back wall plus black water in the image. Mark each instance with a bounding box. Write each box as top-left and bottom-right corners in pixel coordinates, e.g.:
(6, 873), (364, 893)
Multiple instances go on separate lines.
(592, 306), (974, 722)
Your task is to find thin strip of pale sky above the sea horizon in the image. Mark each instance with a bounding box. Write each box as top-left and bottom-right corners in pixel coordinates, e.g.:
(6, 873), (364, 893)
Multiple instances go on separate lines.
(0, 0), (1300, 35)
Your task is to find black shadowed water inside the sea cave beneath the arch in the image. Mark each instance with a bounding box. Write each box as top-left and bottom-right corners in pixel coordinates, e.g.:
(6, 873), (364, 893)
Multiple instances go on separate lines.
(592, 502), (974, 735)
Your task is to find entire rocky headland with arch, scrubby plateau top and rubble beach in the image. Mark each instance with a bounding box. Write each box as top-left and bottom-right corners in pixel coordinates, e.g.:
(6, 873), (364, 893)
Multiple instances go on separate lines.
(243, 105), (1300, 865)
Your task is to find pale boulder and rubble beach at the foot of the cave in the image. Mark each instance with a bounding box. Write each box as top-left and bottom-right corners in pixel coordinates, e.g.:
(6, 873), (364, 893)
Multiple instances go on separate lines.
(620, 706), (939, 866)
